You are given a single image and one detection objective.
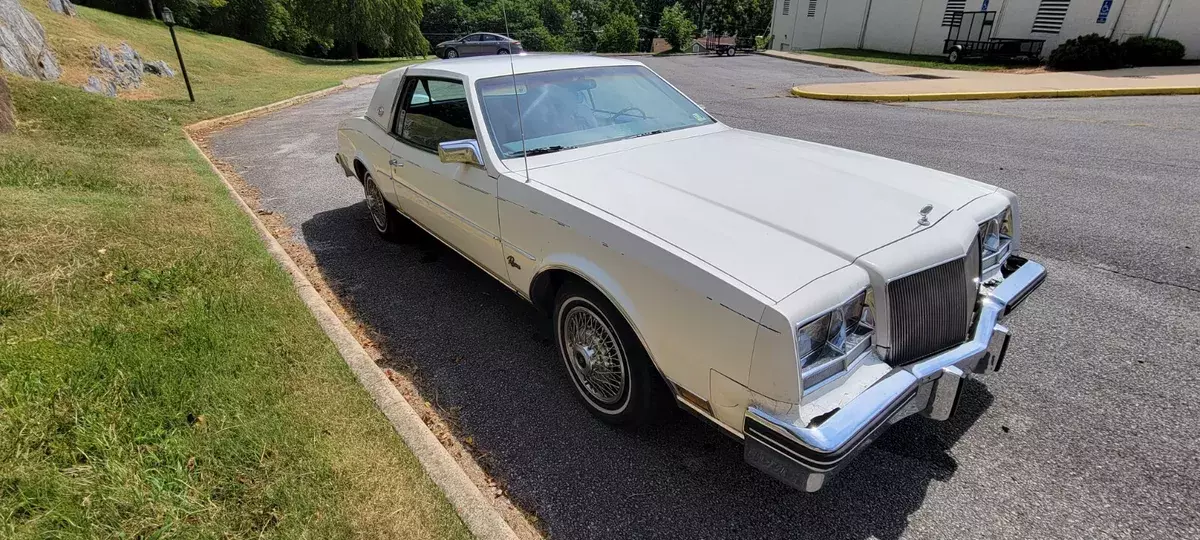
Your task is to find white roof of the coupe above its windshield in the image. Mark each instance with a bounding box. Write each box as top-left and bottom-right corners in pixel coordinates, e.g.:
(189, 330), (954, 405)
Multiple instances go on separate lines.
(409, 54), (642, 79)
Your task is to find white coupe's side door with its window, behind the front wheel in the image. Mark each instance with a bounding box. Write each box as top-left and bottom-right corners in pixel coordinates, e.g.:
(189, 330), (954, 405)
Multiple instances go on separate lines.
(392, 77), (508, 281)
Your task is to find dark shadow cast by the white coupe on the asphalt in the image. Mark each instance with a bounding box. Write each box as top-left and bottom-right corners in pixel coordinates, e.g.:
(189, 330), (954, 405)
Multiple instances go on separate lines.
(301, 203), (992, 540)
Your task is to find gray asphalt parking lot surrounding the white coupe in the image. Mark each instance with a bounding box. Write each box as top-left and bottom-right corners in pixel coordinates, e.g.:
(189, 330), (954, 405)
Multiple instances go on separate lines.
(211, 55), (1200, 539)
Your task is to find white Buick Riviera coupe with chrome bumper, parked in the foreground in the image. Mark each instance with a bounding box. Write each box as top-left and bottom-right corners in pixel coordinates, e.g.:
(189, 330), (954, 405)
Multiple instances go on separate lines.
(337, 55), (1046, 491)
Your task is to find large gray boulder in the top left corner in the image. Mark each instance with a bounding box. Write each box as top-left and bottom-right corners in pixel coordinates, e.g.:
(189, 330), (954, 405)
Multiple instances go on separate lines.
(0, 0), (62, 80)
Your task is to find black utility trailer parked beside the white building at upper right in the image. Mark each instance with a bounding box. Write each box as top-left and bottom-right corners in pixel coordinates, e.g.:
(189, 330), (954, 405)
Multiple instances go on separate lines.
(942, 11), (1045, 64)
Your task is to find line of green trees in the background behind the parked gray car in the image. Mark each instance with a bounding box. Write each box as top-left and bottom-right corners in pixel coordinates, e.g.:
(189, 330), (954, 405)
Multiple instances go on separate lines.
(76, 0), (773, 59)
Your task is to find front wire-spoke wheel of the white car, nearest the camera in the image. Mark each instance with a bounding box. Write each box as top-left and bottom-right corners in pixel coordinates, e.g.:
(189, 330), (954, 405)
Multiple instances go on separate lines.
(562, 306), (629, 406)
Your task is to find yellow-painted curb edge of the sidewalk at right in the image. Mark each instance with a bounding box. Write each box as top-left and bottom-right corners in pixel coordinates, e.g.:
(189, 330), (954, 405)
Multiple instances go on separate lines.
(791, 86), (1200, 101)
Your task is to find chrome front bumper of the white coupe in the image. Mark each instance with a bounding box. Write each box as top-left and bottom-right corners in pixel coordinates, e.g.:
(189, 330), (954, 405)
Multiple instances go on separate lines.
(744, 256), (1046, 492)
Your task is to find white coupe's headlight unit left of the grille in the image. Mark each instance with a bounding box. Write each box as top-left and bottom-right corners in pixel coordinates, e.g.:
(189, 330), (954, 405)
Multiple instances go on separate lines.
(796, 289), (875, 372)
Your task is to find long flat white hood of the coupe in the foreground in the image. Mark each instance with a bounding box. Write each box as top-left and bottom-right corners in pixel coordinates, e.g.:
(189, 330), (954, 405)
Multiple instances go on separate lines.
(530, 128), (996, 301)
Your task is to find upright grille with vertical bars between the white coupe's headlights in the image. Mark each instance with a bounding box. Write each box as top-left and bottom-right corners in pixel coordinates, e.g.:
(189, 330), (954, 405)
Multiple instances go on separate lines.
(888, 258), (974, 365)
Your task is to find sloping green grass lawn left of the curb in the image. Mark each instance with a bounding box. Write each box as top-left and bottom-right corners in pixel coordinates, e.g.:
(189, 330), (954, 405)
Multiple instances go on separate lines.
(0, 0), (468, 539)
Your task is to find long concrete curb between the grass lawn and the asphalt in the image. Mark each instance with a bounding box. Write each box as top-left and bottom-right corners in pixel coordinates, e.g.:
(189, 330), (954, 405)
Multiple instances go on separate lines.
(184, 85), (518, 540)
